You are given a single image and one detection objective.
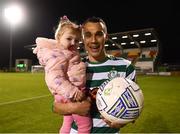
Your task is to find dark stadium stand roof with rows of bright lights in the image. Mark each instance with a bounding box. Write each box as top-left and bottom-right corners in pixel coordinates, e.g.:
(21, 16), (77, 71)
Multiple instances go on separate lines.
(106, 28), (159, 50)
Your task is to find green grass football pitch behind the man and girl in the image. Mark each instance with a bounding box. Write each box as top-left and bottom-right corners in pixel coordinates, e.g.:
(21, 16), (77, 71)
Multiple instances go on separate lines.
(0, 73), (180, 133)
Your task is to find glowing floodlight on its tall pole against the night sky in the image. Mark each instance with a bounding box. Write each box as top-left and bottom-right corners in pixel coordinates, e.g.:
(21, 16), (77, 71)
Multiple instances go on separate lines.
(4, 5), (23, 71)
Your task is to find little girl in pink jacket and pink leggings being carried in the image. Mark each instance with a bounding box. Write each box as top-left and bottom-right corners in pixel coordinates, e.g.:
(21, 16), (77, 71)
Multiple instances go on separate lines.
(33, 16), (92, 133)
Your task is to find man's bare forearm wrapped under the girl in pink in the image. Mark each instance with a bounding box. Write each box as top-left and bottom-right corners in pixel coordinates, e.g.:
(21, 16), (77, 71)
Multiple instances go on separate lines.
(53, 98), (91, 116)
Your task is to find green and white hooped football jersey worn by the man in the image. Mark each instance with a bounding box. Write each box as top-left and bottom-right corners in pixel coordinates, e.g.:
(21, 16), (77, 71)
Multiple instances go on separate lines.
(71, 56), (136, 133)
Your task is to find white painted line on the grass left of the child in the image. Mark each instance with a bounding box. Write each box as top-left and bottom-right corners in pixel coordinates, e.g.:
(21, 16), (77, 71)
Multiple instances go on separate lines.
(0, 95), (51, 106)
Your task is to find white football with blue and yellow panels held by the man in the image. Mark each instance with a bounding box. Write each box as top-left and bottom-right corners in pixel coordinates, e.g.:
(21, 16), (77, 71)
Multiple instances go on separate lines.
(96, 77), (144, 124)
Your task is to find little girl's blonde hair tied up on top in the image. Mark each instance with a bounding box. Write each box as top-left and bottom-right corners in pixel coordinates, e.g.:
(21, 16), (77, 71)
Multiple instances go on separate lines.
(55, 16), (81, 40)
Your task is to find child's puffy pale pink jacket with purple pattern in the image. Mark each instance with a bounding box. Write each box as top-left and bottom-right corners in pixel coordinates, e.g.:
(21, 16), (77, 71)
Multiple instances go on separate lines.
(33, 37), (86, 99)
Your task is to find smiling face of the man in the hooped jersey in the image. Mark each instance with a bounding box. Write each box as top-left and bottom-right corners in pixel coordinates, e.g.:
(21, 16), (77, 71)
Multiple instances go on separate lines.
(82, 22), (107, 62)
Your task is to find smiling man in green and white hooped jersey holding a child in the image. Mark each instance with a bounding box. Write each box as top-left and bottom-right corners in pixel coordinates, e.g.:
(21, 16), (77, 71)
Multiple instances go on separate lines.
(54, 17), (136, 133)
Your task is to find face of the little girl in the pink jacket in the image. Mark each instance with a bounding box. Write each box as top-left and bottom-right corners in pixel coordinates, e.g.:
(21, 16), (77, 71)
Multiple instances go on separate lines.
(59, 29), (81, 50)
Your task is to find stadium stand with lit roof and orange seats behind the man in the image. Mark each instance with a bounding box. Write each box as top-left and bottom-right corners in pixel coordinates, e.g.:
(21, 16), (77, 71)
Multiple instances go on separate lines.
(25, 28), (160, 73)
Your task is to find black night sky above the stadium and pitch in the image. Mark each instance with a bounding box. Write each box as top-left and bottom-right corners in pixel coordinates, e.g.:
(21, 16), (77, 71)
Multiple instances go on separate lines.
(0, 0), (180, 68)
